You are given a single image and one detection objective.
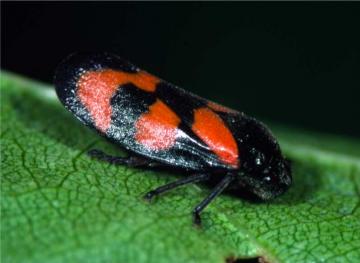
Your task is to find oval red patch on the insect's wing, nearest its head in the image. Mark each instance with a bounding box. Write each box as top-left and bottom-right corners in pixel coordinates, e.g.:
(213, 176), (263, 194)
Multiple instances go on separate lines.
(192, 108), (239, 168)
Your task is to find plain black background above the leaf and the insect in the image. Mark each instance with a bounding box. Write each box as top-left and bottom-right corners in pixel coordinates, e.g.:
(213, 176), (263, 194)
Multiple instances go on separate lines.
(1, 2), (360, 136)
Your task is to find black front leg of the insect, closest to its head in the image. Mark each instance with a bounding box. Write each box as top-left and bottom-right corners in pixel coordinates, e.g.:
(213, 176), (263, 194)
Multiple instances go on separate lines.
(193, 174), (234, 225)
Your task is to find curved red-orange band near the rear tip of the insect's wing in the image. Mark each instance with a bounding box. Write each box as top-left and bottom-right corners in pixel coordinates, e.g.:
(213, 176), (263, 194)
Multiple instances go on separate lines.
(77, 69), (160, 132)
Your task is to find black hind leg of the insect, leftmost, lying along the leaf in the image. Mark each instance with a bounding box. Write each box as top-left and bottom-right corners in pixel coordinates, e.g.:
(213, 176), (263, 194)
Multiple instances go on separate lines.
(88, 149), (154, 167)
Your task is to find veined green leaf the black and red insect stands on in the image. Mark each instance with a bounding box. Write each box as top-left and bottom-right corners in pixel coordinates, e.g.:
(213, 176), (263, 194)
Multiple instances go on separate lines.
(1, 72), (360, 263)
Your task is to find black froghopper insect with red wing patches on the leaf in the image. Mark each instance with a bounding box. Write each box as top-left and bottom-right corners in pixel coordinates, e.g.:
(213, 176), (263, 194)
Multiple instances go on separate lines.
(55, 53), (292, 224)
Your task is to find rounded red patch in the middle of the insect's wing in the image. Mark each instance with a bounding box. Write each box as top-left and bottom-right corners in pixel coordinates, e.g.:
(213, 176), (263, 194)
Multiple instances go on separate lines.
(135, 99), (180, 150)
